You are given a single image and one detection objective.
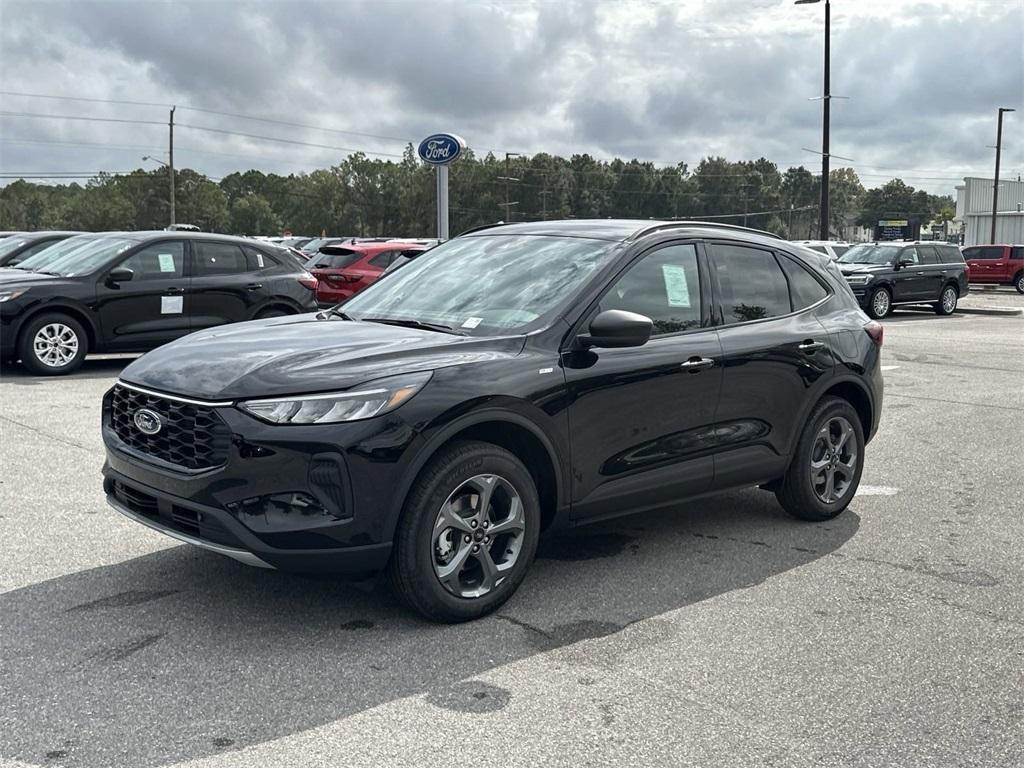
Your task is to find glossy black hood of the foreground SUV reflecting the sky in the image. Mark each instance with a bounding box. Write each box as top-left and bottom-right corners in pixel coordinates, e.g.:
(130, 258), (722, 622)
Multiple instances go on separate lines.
(121, 314), (524, 400)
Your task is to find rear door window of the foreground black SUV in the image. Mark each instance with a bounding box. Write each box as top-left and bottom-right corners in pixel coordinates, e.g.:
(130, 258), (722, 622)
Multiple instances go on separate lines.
(712, 244), (793, 325)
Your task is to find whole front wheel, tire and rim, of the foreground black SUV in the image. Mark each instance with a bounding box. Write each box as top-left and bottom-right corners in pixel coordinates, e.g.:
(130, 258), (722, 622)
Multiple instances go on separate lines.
(389, 441), (541, 623)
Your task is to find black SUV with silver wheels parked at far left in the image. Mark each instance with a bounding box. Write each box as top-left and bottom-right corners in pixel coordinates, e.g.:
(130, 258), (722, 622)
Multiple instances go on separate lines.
(0, 231), (316, 375)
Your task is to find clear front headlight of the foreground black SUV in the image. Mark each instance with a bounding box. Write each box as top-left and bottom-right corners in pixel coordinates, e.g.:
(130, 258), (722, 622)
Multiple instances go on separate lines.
(239, 371), (432, 424)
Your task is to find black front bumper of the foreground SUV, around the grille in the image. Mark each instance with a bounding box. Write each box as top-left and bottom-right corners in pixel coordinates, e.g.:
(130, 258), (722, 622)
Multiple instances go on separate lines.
(102, 387), (419, 574)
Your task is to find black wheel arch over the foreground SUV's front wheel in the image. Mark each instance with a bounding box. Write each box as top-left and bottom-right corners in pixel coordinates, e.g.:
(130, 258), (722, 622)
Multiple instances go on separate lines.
(389, 409), (568, 531)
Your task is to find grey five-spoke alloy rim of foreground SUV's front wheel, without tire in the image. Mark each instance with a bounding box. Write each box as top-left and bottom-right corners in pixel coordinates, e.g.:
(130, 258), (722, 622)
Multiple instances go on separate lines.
(431, 474), (526, 598)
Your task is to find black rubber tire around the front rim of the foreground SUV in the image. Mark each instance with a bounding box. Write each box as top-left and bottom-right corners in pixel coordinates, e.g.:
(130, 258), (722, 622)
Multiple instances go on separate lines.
(388, 441), (541, 623)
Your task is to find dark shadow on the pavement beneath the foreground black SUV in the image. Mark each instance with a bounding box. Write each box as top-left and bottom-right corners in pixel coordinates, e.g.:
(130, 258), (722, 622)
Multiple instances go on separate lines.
(0, 490), (860, 766)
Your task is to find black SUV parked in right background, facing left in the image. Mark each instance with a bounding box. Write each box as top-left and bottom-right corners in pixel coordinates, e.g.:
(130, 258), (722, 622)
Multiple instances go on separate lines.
(837, 243), (970, 319)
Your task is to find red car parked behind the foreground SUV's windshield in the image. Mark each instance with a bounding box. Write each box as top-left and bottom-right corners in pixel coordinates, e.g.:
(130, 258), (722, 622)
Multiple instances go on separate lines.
(306, 241), (427, 306)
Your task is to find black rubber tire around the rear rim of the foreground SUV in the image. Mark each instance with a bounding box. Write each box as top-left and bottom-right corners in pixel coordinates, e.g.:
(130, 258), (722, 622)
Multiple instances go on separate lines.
(775, 397), (864, 521)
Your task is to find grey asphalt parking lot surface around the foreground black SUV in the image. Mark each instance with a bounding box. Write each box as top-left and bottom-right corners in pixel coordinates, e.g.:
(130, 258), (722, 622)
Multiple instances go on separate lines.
(0, 292), (1024, 768)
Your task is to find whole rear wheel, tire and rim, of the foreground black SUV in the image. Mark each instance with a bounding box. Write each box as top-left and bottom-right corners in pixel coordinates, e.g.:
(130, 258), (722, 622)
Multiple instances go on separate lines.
(775, 397), (864, 521)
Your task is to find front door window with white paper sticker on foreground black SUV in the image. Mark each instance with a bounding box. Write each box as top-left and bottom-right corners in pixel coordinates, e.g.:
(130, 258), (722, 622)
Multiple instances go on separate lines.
(599, 245), (700, 336)
